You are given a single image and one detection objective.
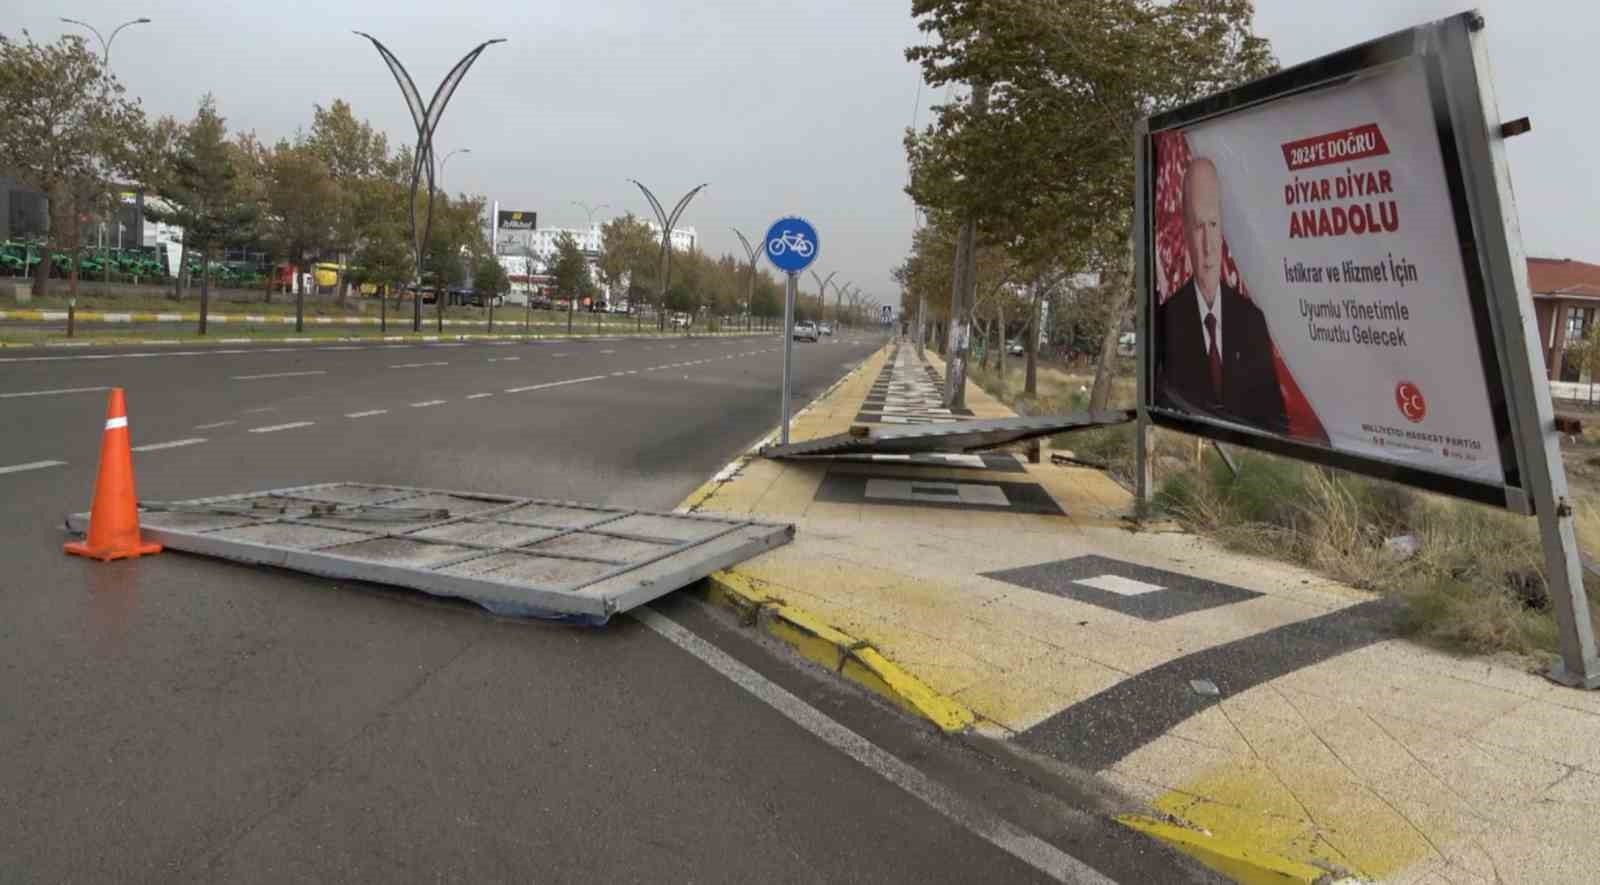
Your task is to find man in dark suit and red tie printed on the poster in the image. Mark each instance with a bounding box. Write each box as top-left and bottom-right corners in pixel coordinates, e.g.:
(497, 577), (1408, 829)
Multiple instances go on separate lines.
(1154, 157), (1290, 434)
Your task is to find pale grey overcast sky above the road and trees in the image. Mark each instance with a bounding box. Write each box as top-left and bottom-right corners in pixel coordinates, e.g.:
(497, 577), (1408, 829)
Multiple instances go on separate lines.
(15, 0), (1600, 302)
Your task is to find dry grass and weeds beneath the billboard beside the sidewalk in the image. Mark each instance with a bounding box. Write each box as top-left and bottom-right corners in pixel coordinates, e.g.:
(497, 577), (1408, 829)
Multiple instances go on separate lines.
(1155, 453), (1600, 658)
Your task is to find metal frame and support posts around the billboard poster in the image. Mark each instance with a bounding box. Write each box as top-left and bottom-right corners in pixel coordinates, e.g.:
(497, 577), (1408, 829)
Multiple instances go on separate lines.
(1134, 11), (1600, 688)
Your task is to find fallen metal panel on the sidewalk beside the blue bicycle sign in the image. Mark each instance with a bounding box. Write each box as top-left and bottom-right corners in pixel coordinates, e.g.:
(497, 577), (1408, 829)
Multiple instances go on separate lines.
(762, 410), (1134, 458)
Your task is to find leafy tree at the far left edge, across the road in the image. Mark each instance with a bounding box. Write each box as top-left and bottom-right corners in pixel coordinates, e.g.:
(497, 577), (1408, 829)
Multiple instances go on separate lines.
(0, 30), (146, 294)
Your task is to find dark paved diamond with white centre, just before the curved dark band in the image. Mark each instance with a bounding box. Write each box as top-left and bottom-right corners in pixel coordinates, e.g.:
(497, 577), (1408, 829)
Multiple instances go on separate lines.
(982, 555), (1261, 621)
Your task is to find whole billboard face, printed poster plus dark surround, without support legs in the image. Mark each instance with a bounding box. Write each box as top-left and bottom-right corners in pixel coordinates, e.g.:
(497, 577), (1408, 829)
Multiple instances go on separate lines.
(1139, 12), (1531, 509)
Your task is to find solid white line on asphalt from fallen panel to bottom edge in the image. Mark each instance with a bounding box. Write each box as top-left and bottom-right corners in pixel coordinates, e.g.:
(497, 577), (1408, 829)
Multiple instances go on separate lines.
(632, 608), (1112, 885)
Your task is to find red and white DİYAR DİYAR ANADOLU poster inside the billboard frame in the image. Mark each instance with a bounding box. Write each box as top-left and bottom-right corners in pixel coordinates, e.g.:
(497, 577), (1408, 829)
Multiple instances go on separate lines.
(1149, 59), (1506, 483)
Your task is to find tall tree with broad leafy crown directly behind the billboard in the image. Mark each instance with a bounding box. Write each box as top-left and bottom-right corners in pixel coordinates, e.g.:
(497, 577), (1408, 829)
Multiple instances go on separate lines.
(906, 0), (1274, 408)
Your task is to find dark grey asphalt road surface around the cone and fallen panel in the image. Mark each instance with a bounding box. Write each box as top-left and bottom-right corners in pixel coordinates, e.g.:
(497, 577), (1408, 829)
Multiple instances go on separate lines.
(0, 336), (1210, 882)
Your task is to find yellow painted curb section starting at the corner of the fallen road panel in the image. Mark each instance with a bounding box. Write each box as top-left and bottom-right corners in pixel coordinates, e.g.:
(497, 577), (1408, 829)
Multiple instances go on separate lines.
(704, 571), (976, 733)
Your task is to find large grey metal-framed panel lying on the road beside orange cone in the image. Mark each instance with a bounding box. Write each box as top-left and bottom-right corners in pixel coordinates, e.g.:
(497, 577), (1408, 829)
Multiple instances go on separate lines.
(67, 483), (794, 624)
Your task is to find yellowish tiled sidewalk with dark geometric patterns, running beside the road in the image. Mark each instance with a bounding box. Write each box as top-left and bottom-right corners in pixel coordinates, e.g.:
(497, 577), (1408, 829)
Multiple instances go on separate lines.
(685, 339), (1600, 883)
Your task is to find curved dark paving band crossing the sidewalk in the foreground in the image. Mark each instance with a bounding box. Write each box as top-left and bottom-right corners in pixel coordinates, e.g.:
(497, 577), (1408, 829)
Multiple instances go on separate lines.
(1016, 600), (1395, 771)
